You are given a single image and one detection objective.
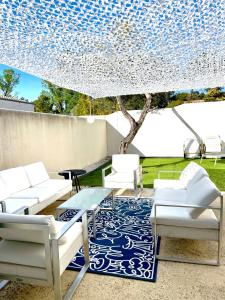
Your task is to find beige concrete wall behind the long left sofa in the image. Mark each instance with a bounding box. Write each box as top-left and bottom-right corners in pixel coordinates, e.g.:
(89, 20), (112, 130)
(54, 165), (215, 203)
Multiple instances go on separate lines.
(0, 109), (107, 171)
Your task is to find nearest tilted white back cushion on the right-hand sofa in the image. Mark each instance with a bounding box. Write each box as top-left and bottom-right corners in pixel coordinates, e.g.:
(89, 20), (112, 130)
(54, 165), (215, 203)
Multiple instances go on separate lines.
(187, 176), (221, 218)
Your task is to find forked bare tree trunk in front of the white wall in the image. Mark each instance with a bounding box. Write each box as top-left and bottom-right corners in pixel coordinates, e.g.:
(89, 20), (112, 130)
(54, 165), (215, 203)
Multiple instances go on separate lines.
(116, 94), (152, 154)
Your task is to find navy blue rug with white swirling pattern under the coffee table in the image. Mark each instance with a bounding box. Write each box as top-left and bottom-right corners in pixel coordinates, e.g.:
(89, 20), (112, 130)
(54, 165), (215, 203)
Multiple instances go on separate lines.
(59, 198), (159, 282)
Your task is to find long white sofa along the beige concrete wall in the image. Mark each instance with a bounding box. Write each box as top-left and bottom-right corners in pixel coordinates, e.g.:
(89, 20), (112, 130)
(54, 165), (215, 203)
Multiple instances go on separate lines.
(0, 162), (72, 214)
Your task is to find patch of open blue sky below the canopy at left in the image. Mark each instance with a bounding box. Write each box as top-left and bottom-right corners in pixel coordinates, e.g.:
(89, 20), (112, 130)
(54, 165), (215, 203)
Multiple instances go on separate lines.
(0, 64), (42, 101)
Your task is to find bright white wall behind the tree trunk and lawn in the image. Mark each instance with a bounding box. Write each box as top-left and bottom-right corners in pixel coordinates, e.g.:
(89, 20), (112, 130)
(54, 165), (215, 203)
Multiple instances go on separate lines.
(107, 101), (225, 157)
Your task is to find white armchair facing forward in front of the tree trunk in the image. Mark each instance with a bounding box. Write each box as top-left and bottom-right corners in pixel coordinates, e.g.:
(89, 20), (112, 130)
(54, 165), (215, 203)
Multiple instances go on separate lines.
(102, 154), (143, 198)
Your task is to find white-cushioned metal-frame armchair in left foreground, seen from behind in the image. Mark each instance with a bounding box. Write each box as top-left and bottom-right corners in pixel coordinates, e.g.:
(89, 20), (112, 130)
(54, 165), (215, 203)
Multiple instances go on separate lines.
(0, 211), (89, 299)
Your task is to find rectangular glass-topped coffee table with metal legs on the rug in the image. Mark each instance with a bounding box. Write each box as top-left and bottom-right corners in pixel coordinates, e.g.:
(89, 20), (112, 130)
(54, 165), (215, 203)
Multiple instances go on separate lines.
(57, 188), (114, 238)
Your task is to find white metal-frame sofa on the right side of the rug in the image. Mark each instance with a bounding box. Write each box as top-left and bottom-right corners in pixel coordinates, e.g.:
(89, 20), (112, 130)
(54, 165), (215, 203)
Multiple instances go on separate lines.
(150, 167), (223, 265)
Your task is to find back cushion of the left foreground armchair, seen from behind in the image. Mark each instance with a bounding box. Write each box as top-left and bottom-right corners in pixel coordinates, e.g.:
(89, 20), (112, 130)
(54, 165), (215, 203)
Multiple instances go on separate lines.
(0, 213), (56, 243)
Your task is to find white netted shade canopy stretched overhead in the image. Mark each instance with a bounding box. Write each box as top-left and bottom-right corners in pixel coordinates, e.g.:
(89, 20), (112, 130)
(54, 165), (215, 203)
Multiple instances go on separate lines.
(0, 0), (225, 98)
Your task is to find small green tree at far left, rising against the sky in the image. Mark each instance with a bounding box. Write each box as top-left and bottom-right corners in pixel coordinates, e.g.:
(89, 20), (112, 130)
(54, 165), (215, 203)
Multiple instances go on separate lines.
(0, 69), (20, 97)
